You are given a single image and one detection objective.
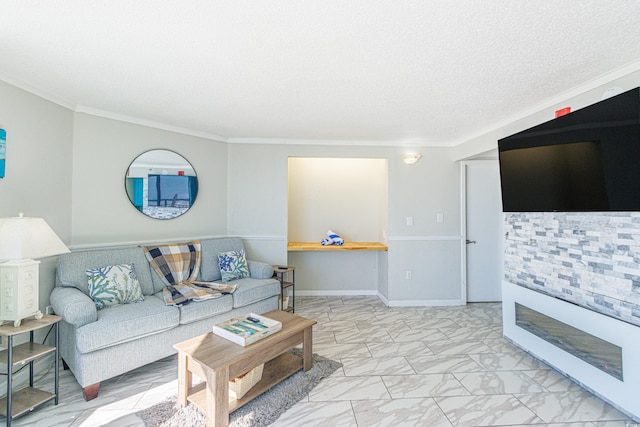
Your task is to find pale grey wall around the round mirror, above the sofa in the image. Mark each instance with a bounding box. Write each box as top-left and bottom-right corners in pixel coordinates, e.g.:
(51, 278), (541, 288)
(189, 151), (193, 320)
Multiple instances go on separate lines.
(72, 113), (227, 247)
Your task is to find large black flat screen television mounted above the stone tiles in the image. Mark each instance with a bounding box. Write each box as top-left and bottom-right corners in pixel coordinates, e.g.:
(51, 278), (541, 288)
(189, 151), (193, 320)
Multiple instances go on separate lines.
(498, 88), (640, 212)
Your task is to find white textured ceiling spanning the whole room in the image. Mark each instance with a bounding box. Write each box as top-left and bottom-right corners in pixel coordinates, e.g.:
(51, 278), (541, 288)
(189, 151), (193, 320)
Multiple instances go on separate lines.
(0, 0), (640, 145)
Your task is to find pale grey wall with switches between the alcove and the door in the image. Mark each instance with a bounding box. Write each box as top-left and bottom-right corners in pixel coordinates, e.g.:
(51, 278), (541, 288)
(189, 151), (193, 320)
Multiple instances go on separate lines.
(388, 148), (463, 305)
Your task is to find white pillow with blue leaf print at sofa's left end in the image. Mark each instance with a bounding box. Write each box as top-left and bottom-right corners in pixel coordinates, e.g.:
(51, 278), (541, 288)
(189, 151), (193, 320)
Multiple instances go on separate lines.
(86, 264), (144, 310)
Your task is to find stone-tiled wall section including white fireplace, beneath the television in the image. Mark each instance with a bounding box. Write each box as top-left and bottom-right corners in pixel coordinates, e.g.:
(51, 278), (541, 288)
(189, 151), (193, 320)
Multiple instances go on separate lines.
(503, 212), (640, 420)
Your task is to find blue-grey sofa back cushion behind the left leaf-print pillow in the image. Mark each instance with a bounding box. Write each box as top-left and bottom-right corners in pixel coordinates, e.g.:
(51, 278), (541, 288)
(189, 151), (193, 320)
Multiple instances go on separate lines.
(56, 247), (154, 296)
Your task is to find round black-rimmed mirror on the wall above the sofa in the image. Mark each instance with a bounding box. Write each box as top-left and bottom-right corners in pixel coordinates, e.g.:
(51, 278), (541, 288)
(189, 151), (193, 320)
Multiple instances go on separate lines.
(125, 150), (198, 219)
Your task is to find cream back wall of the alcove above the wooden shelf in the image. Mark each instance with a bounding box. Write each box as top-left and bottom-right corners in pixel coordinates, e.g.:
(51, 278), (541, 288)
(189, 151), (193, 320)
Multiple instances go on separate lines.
(287, 157), (388, 245)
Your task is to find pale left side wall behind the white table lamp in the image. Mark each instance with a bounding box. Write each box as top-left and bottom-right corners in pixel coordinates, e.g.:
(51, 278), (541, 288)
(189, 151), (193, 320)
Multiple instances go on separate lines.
(0, 81), (73, 312)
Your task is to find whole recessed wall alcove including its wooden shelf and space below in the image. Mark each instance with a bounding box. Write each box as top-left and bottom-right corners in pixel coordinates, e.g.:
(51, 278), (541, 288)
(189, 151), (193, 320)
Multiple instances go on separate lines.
(287, 157), (389, 295)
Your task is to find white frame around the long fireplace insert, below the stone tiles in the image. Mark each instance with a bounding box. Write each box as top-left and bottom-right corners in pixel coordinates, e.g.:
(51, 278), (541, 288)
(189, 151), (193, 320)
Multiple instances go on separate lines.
(502, 281), (640, 421)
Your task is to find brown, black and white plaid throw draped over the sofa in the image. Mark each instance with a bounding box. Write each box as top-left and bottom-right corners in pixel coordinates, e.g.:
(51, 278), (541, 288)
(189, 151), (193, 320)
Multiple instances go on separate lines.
(143, 240), (230, 305)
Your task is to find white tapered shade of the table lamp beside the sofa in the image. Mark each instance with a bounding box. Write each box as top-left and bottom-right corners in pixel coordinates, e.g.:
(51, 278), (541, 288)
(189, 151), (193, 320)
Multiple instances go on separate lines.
(0, 216), (70, 261)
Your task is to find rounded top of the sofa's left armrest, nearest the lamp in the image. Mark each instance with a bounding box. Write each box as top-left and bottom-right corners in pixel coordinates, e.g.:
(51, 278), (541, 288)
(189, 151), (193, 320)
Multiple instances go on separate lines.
(50, 286), (98, 328)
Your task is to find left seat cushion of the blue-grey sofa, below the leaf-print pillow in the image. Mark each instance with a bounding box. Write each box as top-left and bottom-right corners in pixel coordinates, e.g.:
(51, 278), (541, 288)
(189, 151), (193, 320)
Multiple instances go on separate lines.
(76, 297), (180, 354)
